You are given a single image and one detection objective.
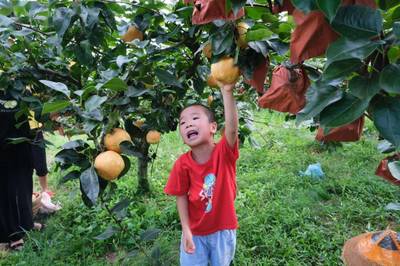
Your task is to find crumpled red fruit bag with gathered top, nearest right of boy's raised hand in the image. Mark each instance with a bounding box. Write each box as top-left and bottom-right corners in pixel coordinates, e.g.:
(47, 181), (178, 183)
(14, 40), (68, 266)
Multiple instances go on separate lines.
(258, 66), (310, 114)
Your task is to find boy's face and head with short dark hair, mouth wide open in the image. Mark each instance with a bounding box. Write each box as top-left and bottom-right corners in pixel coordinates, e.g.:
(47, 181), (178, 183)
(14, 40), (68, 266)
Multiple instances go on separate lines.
(179, 105), (217, 147)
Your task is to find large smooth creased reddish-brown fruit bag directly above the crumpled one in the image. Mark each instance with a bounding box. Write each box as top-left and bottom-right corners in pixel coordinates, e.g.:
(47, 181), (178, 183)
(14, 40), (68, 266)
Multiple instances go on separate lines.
(290, 9), (339, 64)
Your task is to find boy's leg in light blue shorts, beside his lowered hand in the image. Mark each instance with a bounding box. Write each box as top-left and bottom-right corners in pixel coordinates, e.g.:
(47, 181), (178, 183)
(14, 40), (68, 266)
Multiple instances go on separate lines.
(180, 236), (209, 266)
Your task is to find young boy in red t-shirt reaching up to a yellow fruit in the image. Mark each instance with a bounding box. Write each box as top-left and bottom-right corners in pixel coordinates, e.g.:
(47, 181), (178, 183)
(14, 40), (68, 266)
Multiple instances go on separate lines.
(164, 84), (239, 266)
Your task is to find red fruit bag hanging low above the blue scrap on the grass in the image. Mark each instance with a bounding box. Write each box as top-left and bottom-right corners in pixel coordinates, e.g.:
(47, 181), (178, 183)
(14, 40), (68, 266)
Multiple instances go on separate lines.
(315, 116), (364, 142)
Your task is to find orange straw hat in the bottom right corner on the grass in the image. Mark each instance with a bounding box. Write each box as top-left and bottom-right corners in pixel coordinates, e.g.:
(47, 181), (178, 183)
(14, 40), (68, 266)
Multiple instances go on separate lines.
(342, 230), (400, 266)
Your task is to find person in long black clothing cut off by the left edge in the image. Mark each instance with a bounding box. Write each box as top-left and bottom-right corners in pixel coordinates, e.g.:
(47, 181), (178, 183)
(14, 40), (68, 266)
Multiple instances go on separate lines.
(0, 95), (34, 249)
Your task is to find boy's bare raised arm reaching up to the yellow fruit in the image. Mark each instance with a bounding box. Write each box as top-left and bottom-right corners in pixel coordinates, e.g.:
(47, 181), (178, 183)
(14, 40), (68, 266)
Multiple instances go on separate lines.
(218, 83), (239, 147)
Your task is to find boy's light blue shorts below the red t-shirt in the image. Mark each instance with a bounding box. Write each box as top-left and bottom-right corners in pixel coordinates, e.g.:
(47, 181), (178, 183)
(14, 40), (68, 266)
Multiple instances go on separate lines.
(180, 230), (236, 266)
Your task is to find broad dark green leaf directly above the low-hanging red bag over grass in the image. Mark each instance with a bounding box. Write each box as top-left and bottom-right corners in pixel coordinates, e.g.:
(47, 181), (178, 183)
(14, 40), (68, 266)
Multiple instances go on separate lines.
(320, 94), (369, 128)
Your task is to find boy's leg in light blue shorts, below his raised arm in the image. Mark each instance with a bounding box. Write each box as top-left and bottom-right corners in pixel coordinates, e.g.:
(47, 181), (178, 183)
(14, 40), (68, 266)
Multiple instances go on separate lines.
(208, 230), (236, 266)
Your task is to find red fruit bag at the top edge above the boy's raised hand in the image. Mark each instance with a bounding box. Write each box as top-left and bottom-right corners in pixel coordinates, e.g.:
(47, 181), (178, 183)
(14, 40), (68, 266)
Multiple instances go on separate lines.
(188, 0), (244, 24)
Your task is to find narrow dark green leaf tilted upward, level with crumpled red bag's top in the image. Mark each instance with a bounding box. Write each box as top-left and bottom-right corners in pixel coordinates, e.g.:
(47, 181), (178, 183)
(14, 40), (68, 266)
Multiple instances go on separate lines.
(322, 58), (362, 80)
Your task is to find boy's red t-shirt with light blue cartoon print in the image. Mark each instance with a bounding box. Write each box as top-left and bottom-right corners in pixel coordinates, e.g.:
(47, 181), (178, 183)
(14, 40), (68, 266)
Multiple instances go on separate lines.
(164, 135), (239, 235)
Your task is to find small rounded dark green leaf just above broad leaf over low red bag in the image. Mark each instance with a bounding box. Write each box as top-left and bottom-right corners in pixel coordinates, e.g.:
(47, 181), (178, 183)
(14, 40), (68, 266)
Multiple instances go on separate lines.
(349, 74), (381, 99)
